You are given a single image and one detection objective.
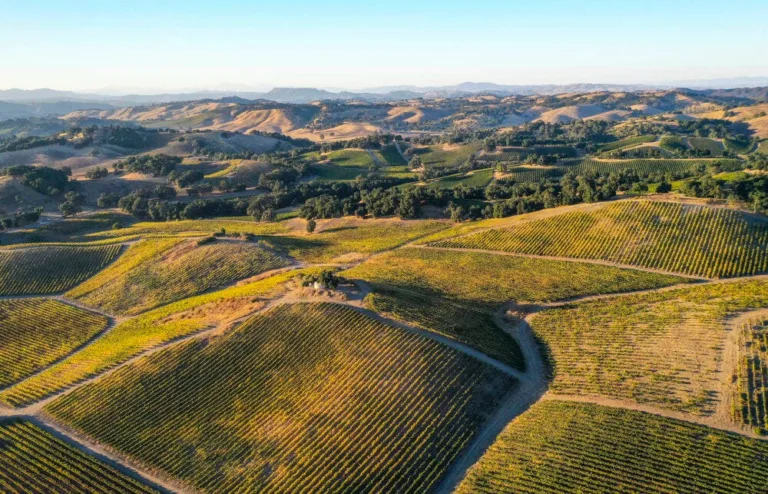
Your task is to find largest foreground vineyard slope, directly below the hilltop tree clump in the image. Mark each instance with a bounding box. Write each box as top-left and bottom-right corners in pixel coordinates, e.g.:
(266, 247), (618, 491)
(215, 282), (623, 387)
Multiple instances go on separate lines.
(47, 304), (515, 492)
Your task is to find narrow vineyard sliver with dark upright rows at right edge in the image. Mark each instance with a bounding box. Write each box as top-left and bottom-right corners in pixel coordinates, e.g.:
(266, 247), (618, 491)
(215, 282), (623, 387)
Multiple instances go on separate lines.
(733, 320), (768, 435)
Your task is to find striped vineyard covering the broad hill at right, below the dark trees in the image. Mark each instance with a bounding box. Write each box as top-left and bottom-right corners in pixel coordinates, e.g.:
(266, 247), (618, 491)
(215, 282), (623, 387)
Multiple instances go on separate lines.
(434, 201), (768, 278)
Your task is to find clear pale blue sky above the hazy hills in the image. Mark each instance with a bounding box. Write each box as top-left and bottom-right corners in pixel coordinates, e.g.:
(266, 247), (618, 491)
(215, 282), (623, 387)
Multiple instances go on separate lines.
(0, 0), (768, 93)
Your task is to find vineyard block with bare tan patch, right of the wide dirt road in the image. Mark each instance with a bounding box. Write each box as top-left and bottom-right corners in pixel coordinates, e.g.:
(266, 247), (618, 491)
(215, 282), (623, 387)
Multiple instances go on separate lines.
(531, 280), (768, 415)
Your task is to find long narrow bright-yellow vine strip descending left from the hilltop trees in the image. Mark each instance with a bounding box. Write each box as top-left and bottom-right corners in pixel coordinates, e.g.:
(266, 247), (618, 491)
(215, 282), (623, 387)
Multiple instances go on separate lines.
(0, 269), (318, 407)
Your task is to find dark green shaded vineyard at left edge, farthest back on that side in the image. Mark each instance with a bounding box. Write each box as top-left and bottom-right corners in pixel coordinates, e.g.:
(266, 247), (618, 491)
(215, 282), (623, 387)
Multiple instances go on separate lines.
(0, 244), (121, 295)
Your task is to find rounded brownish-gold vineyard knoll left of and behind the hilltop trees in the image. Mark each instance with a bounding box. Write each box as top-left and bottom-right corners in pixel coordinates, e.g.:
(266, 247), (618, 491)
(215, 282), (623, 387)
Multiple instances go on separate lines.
(68, 239), (289, 315)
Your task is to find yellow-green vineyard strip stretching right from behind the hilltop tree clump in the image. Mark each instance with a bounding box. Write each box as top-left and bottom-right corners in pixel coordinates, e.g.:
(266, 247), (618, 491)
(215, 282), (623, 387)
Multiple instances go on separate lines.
(342, 248), (684, 308)
